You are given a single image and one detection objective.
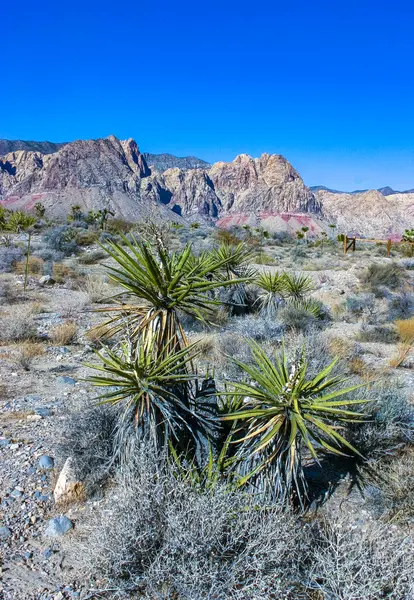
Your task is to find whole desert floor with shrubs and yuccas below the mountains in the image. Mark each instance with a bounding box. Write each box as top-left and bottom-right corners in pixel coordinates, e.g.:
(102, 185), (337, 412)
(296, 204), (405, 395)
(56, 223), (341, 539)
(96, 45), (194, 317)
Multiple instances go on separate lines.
(0, 217), (414, 600)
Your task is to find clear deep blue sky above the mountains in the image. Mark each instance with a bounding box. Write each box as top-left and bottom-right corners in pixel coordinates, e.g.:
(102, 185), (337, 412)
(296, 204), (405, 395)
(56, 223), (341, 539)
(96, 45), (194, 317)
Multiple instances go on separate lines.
(0, 0), (414, 190)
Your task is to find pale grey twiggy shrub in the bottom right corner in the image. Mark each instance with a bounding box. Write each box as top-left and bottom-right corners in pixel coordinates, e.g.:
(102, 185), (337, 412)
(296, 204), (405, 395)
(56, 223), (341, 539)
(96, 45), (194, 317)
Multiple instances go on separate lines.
(306, 517), (414, 600)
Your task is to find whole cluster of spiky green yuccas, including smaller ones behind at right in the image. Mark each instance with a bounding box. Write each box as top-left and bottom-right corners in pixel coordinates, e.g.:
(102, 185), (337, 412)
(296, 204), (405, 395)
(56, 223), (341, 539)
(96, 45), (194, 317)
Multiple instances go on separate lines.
(86, 229), (364, 509)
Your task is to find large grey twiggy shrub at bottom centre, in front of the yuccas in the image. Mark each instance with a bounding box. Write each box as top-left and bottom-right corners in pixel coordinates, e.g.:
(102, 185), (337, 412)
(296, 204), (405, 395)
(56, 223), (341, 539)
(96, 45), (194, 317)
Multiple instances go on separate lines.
(81, 450), (303, 600)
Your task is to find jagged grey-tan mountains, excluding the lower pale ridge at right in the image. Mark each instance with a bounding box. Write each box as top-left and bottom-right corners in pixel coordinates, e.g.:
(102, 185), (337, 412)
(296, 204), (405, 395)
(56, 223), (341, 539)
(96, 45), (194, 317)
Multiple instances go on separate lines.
(0, 136), (320, 225)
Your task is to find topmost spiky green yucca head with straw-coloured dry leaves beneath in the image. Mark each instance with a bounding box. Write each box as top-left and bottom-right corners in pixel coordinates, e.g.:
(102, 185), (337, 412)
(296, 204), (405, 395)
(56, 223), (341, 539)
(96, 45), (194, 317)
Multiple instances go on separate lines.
(98, 237), (251, 354)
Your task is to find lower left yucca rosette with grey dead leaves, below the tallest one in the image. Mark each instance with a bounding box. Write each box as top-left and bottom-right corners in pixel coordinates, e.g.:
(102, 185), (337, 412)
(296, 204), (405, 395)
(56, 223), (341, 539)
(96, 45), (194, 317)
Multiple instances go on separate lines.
(87, 340), (204, 449)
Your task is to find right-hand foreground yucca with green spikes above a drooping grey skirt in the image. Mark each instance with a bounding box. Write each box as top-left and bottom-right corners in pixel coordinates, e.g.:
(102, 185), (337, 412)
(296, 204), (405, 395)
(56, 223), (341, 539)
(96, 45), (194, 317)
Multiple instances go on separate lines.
(222, 341), (368, 509)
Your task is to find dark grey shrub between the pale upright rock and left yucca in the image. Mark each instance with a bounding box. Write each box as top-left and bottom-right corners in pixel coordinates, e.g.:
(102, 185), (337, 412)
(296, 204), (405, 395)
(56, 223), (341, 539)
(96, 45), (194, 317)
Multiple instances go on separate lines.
(56, 405), (118, 494)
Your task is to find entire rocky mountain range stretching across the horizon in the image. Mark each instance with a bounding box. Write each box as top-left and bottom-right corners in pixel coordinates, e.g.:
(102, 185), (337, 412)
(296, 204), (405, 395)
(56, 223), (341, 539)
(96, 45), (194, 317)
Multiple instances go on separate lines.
(0, 136), (414, 237)
